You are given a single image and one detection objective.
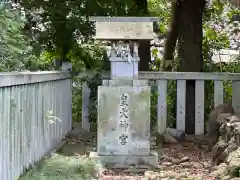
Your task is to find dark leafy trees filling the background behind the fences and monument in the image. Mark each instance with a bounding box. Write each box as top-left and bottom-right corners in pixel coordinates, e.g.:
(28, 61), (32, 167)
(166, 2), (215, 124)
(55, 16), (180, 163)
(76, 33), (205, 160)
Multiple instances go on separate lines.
(0, 0), (240, 130)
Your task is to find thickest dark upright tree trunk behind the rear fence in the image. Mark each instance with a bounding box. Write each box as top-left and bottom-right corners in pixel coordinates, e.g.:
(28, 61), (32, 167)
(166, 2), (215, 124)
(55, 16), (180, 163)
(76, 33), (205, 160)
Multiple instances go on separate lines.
(178, 0), (205, 134)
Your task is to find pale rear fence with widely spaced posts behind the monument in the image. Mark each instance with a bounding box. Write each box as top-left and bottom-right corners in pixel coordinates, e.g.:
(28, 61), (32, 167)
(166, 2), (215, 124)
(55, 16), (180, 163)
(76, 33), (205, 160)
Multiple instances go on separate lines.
(79, 71), (240, 135)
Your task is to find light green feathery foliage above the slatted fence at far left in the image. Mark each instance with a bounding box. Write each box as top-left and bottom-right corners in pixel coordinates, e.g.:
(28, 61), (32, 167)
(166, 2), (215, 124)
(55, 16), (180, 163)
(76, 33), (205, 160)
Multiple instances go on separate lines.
(0, 8), (53, 72)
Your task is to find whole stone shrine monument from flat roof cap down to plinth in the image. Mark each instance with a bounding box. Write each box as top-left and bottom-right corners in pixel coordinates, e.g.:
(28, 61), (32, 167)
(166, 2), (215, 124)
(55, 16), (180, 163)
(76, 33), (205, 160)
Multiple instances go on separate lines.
(90, 17), (159, 168)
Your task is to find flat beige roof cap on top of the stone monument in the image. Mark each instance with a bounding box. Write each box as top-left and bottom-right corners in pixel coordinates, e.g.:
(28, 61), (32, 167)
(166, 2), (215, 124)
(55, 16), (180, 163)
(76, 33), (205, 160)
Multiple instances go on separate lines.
(89, 16), (159, 40)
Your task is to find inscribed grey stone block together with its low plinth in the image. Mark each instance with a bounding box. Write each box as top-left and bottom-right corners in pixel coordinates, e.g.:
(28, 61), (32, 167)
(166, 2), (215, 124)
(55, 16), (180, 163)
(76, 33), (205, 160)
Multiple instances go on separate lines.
(90, 86), (158, 168)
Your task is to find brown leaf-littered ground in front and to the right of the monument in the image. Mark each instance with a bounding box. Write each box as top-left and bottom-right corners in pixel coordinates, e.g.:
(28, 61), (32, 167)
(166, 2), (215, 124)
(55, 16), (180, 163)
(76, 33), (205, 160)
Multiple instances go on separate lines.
(100, 142), (215, 180)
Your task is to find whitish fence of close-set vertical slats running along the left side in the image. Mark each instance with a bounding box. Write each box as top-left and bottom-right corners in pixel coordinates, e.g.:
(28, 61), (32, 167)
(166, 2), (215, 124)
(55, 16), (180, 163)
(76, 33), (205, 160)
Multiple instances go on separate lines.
(0, 72), (72, 180)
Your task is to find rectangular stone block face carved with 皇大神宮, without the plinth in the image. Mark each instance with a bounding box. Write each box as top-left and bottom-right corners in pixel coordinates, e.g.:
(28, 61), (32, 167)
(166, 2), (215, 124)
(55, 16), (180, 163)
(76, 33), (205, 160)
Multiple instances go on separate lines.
(97, 86), (150, 156)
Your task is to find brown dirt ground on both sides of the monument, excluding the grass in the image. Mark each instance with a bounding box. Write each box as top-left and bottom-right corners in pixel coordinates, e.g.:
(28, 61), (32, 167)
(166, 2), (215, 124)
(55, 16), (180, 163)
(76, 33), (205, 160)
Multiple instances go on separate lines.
(59, 133), (215, 180)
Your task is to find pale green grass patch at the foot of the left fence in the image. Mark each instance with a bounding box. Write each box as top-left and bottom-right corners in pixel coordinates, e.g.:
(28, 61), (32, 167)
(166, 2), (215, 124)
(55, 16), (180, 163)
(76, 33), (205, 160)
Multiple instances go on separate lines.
(19, 154), (102, 180)
